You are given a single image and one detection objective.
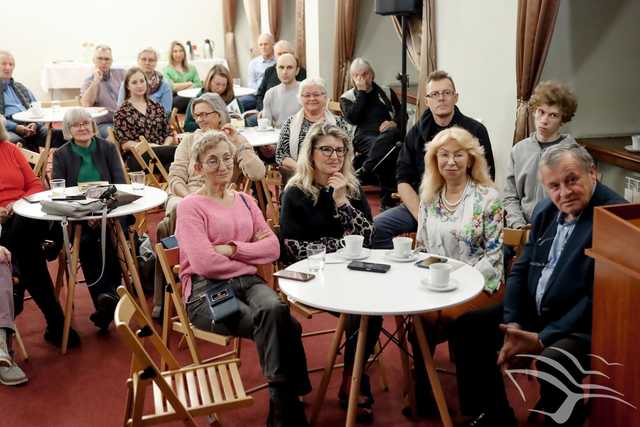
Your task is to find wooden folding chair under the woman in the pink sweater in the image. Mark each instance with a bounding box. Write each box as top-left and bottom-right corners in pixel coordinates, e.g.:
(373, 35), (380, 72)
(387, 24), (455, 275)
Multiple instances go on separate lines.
(156, 243), (240, 363)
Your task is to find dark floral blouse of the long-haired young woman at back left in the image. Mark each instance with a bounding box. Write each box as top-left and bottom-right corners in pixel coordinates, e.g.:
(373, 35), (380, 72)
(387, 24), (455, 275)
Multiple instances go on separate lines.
(113, 99), (171, 145)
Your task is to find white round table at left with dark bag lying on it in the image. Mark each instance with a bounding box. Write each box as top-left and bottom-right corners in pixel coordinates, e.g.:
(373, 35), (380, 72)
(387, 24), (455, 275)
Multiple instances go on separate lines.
(13, 184), (167, 354)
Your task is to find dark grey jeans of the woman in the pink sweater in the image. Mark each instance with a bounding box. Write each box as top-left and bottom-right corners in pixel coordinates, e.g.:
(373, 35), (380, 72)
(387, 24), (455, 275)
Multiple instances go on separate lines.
(187, 276), (311, 395)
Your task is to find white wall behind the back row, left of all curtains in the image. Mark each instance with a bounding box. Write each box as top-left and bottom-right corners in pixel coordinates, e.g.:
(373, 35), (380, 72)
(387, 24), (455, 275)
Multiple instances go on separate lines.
(0, 0), (225, 98)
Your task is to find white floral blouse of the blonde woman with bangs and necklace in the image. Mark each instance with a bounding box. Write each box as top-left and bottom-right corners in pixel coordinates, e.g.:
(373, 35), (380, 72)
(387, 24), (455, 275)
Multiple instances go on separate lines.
(416, 181), (503, 293)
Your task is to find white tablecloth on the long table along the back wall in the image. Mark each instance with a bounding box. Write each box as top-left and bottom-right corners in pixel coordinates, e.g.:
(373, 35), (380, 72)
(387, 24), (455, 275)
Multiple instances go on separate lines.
(40, 58), (228, 92)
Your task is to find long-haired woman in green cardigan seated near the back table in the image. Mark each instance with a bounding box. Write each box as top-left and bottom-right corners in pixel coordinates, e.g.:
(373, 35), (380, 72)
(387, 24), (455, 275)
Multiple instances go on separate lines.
(162, 40), (202, 114)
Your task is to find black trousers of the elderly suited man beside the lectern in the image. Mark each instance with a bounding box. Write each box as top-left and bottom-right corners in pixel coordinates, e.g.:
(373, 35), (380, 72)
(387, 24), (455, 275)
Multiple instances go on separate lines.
(451, 304), (591, 427)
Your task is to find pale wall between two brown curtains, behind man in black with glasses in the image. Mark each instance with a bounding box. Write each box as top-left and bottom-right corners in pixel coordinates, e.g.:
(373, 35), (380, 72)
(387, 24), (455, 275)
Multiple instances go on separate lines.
(436, 0), (517, 188)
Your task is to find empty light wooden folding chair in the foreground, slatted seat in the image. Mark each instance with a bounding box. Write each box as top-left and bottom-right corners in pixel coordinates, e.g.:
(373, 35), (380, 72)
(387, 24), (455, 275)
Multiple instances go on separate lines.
(114, 286), (253, 427)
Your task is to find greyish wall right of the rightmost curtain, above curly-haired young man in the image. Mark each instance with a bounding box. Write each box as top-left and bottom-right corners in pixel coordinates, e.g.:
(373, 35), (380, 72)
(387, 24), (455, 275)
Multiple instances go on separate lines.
(542, 0), (640, 137)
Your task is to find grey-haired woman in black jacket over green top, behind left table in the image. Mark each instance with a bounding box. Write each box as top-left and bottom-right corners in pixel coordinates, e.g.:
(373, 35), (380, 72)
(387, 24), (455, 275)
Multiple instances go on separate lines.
(53, 108), (125, 332)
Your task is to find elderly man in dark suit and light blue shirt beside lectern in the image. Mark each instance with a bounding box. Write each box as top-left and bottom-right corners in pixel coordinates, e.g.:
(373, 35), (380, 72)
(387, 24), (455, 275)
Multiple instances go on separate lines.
(453, 142), (625, 427)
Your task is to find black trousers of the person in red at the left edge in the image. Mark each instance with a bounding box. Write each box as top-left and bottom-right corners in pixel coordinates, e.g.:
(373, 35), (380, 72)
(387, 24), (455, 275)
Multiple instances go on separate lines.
(0, 214), (64, 331)
